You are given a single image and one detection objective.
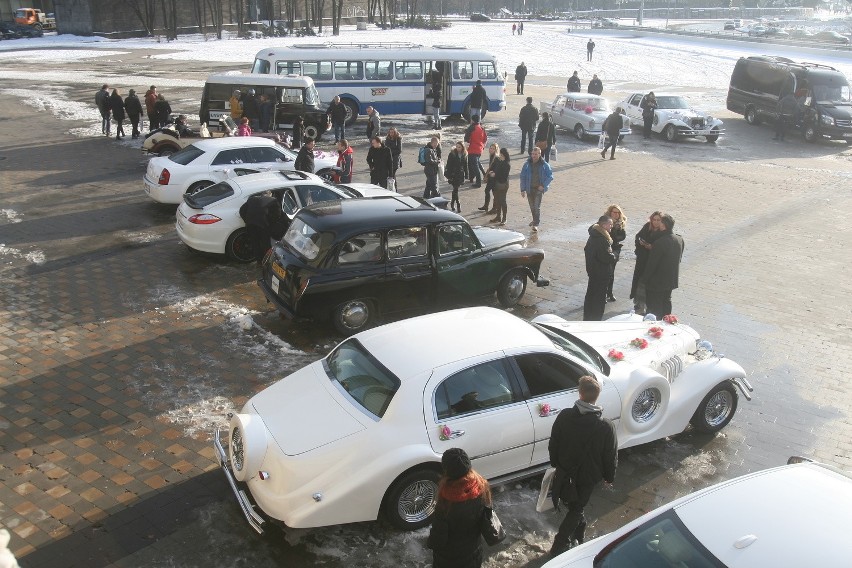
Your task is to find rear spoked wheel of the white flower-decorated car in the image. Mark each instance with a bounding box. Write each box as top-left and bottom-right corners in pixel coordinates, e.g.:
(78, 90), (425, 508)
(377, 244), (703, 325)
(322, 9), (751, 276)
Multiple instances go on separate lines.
(384, 467), (441, 531)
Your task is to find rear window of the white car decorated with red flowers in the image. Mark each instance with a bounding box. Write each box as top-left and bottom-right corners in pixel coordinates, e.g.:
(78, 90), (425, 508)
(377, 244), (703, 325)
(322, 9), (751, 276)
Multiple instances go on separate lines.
(325, 339), (400, 418)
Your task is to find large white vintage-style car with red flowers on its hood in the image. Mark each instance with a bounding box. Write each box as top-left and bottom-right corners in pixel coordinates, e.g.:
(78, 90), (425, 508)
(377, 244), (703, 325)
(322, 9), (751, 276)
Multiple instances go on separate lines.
(214, 307), (751, 532)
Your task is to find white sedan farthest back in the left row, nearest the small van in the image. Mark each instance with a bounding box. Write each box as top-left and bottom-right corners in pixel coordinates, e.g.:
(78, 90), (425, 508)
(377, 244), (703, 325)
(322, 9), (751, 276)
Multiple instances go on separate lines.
(143, 136), (337, 204)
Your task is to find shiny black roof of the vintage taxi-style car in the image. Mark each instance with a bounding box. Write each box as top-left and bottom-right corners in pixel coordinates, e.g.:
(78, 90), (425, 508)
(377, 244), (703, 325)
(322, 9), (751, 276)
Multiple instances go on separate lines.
(297, 194), (465, 235)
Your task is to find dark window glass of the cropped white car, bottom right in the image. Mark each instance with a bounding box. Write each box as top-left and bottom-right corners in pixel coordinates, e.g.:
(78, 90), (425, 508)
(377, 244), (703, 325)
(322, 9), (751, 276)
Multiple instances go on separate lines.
(594, 509), (725, 568)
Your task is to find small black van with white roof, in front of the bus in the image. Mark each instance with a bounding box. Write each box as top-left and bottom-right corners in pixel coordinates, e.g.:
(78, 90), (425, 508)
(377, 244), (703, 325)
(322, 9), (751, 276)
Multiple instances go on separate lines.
(198, 74), (329, 140)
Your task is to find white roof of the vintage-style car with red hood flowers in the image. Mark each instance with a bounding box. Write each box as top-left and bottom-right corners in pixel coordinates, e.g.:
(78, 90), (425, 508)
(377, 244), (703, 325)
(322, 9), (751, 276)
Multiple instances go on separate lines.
(354, 306), (553, 381)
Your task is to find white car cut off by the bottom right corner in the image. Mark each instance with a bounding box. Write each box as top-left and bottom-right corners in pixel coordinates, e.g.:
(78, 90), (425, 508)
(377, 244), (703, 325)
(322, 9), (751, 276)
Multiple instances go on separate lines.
(544, 458), (852, 568)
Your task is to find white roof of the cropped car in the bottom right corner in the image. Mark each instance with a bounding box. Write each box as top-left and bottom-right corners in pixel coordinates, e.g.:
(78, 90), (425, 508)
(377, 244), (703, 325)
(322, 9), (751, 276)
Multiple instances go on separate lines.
(674, 463), (852, 568)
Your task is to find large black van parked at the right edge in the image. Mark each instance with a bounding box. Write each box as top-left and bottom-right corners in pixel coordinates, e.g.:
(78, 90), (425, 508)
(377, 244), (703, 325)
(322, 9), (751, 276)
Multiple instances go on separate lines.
(727, 55), (852, 144)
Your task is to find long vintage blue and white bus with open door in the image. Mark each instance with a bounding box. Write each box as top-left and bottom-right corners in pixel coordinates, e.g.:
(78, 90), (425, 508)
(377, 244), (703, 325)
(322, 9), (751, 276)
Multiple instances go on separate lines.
(252, 43), (506, 124)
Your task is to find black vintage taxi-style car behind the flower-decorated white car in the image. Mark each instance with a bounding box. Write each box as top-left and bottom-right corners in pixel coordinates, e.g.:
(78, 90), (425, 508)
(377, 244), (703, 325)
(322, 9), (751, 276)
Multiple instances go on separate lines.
(258, 195), (548, 335)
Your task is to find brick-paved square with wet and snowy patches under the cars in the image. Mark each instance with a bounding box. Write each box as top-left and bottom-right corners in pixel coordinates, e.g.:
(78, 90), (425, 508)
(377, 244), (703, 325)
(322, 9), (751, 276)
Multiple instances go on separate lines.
(0, 45), (852, 568)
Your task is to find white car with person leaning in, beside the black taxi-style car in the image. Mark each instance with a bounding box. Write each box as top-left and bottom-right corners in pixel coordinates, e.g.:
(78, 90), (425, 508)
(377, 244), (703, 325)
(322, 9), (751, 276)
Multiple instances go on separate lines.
(175, 171), (397, 262)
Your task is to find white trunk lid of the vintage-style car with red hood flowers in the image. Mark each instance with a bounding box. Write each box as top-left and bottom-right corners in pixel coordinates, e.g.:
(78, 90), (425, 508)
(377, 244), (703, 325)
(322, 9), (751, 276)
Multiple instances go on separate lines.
(249, 361), (364, 456)
